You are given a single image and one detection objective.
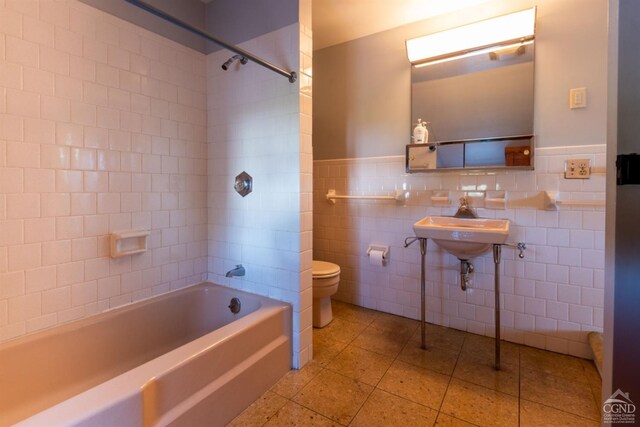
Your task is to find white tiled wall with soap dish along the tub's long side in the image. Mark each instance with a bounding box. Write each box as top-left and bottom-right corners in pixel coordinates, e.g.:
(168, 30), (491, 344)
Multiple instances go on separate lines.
(0, 0), (207, 341)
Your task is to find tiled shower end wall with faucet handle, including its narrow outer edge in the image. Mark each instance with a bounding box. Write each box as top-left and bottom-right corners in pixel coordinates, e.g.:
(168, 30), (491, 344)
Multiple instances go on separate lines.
(207, 1), (312, 367)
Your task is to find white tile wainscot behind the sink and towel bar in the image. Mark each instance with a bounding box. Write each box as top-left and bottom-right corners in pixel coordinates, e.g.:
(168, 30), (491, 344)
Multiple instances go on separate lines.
(313, 145), (605, 357)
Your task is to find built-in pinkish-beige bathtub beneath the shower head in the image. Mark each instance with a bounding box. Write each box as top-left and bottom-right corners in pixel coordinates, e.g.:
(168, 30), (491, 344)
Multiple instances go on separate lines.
(0, 283), (292, 427)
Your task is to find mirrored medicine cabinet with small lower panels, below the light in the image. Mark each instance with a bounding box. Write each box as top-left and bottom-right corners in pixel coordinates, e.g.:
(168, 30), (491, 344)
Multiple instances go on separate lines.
(406, 38), (534, 172)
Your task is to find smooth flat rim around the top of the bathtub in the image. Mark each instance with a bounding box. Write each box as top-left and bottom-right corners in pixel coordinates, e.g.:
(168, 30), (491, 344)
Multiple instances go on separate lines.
(14, 281), (293, 427)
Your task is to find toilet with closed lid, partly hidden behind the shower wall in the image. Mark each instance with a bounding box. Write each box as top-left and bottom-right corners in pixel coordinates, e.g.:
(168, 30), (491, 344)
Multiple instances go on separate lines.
(312, 260), (340, 328)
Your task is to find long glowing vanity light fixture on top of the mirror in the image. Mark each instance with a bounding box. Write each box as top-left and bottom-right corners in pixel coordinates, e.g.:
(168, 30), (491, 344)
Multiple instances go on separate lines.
(407, 7), (536, 67)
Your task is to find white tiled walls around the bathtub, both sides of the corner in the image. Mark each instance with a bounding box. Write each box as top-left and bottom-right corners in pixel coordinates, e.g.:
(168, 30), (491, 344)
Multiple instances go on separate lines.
(0, 0), (313, 366)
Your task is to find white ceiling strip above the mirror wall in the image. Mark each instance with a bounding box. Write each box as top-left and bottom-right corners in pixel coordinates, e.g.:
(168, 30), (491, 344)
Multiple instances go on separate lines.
(312, 0), (488, 49)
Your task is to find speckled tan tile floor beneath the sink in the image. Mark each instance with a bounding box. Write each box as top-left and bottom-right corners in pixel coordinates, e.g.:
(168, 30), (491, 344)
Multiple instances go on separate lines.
(229, 302), (601, 427)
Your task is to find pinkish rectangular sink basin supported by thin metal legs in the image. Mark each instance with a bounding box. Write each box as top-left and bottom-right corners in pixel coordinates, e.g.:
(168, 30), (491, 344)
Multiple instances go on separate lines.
(413, 216), (509, 260)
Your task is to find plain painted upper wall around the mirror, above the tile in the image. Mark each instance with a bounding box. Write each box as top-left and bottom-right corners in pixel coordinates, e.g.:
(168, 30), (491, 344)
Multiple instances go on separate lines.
(314, 0), (607, 160)
